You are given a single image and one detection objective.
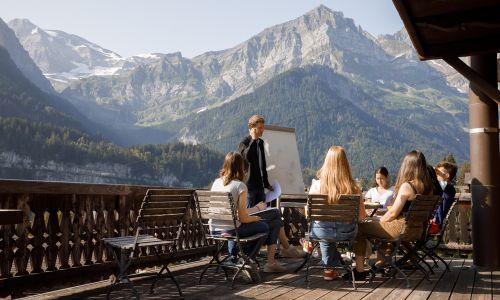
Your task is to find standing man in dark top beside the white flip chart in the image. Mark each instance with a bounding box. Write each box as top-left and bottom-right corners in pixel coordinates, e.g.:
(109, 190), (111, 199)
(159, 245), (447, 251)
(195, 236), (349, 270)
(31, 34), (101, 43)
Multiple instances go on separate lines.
(238, 115), (273, 207)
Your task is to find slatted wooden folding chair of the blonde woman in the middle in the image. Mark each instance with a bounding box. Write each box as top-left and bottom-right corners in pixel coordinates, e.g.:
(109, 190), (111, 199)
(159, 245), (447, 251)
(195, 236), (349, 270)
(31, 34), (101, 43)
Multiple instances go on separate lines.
(305, 194), (360, 289)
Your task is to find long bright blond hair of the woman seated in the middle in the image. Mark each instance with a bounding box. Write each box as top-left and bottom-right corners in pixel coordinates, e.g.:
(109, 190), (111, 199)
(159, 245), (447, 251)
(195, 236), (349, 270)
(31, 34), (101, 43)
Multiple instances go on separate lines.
(316, 146), (361, 204)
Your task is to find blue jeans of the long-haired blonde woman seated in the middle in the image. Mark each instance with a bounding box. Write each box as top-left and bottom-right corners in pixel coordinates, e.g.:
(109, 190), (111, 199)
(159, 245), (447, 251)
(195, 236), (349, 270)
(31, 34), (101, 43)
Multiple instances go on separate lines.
(311, 221), (358, 267)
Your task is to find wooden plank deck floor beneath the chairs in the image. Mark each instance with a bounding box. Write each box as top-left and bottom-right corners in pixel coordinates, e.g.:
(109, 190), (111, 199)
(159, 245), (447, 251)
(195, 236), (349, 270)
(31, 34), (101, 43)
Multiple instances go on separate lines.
(22, 259), (500, 300)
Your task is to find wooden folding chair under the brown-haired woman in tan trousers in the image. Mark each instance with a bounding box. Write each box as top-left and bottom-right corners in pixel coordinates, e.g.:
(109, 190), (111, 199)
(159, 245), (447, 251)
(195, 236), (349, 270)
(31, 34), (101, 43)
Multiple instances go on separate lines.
(368, 194), (441, 287)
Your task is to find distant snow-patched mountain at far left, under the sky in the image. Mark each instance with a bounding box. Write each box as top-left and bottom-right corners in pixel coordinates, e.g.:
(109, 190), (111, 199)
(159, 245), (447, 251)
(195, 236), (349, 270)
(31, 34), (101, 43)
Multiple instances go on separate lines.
(9, 19), (161, 91)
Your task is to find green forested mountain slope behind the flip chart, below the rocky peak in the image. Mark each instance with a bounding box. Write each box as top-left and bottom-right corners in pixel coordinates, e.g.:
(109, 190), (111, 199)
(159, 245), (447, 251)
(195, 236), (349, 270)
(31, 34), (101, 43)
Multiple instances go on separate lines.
(177, 65), (468, 180)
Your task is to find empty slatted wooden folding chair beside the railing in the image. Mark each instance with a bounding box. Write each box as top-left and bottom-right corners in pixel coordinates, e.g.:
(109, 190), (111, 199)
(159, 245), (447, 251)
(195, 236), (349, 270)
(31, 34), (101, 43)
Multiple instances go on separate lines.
(103, 189), (193, 299)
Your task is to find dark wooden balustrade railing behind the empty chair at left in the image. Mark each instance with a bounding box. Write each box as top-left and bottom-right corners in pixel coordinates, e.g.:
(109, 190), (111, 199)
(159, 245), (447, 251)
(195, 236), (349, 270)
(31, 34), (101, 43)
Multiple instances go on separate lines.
(0, 180), (212, 296)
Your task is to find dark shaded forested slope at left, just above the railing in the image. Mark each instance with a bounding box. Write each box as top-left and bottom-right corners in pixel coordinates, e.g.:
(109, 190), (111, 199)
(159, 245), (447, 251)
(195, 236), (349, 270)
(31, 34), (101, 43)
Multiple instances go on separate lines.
(0, 46), (222, 187)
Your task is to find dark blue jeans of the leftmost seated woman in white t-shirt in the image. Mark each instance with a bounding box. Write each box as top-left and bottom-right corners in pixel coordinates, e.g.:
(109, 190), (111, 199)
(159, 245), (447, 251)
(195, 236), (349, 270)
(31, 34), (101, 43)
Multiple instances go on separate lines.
(211, 221), (269, 258)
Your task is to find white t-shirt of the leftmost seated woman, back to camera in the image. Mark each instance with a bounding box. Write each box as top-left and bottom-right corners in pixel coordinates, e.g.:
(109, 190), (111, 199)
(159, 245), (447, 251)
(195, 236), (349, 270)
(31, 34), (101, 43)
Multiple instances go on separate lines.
(208, 178), (247, 231)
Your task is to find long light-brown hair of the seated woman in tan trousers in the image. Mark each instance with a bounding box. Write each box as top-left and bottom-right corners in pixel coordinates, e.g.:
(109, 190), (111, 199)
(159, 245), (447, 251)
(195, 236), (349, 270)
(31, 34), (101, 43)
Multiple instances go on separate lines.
(394, 150), (433, 197)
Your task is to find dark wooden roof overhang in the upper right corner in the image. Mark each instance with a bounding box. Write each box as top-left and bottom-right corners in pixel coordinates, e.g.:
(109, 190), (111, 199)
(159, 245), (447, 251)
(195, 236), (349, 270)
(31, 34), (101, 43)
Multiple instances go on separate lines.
(393, 0), (500, 60)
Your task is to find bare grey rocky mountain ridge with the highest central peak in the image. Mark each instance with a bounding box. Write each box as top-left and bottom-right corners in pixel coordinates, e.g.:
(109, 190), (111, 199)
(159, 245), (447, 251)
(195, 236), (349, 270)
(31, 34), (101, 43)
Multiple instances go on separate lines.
(13, 6), (454, 132)
